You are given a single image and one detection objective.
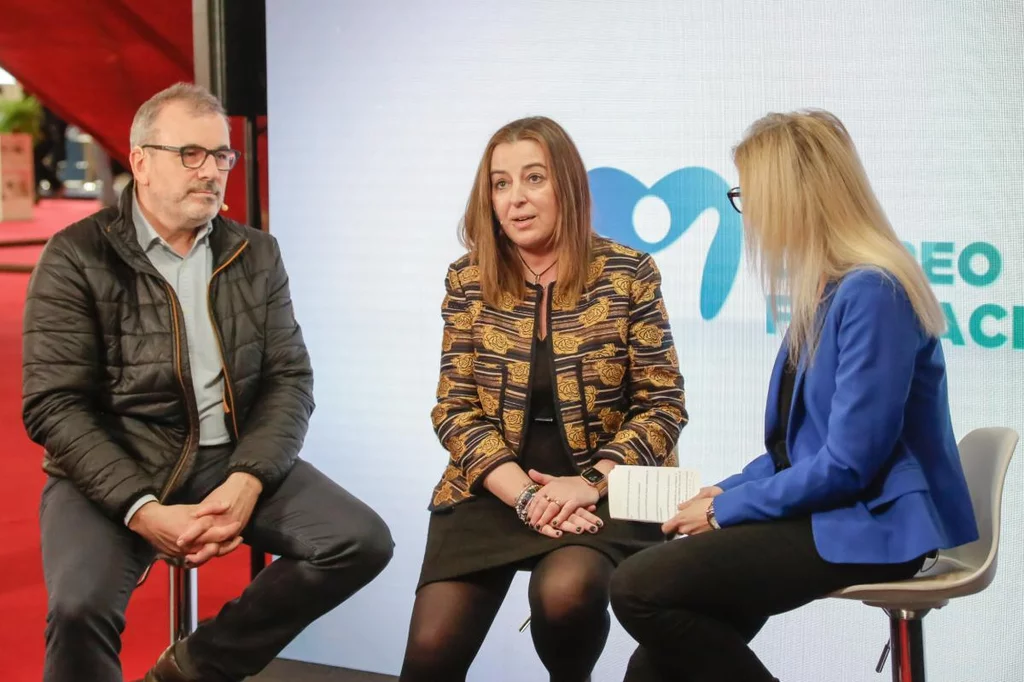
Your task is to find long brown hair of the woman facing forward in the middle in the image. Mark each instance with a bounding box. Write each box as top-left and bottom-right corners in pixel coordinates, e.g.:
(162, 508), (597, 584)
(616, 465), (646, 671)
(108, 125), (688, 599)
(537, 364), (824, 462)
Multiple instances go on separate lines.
(459, 116), (593, 306)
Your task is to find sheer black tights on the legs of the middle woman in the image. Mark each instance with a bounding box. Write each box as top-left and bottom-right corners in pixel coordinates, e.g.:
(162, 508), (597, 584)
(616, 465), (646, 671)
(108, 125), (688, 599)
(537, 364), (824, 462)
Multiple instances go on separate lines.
(398, 546), (614, 682)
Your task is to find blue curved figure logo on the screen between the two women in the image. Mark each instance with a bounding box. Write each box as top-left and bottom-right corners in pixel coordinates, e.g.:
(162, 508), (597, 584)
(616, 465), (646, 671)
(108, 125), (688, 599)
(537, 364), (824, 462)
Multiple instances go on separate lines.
(588, 167), (743, 319)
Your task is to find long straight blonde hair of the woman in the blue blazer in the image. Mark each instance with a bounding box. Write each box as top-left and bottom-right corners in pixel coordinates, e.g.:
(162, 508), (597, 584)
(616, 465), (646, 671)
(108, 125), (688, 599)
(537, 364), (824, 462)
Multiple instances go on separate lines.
(733, 110), (945, 363)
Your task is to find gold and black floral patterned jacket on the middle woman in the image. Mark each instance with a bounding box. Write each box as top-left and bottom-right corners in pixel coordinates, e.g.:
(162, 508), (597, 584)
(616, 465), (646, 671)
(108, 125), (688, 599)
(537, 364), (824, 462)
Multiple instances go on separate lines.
(429, 238), (687, 510)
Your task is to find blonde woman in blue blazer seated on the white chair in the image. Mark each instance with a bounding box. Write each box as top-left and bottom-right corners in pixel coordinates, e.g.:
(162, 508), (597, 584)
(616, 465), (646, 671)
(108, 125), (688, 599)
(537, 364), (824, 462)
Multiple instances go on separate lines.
(611, 112), (978, 682)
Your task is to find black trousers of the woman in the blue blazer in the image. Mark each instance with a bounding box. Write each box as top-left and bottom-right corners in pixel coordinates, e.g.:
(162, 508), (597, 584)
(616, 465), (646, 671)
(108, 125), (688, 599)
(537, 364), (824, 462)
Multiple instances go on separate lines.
(611, 518), (923, 682)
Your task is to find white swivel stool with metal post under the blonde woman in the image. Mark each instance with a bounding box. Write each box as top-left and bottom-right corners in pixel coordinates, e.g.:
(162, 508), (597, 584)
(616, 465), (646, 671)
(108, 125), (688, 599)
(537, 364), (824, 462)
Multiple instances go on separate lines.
(831, 428), (1018, 682)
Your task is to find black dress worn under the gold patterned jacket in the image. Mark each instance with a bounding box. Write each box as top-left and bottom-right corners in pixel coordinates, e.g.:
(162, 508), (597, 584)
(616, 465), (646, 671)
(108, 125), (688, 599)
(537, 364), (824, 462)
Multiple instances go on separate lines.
(417, 340), (665, 590)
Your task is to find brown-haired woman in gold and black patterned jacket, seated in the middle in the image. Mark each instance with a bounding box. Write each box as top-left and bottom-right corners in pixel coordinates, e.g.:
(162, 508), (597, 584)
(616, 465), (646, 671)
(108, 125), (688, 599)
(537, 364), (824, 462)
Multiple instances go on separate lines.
(400, 117), (686, 682)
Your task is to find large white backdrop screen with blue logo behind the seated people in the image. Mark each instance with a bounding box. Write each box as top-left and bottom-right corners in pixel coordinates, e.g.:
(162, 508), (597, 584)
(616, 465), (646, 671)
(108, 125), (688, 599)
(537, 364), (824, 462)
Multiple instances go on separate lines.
(267, 0), (1024, 682)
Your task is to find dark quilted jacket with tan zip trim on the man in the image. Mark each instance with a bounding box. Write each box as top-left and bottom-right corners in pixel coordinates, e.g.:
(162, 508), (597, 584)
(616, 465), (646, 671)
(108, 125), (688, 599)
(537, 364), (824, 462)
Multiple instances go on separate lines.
(23, 185), (313, 517)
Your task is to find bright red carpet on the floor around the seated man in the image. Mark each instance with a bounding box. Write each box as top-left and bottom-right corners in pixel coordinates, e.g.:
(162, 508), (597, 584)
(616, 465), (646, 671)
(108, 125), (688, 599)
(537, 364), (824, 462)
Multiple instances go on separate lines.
(0, 201), (249, 682)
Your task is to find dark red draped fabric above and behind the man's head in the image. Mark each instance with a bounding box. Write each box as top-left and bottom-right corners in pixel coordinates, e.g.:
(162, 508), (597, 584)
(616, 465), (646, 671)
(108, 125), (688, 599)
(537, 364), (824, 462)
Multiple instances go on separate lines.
(0, 0), (267, 227)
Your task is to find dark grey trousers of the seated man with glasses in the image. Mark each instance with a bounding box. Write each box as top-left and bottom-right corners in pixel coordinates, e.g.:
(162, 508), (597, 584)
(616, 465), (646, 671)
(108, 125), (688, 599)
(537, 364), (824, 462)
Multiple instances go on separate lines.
(40, 446), (393, 682)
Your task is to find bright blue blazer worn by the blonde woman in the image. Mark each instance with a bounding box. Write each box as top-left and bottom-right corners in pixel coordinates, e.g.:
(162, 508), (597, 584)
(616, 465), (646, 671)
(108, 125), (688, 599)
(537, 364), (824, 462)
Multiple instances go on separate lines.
(715, 269), (978, 563)
